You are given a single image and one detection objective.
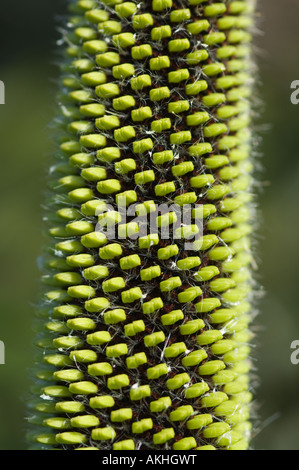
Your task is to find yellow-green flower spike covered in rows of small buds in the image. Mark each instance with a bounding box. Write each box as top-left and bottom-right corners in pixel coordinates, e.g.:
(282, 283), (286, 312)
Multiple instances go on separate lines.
(29, 0), (254, 450)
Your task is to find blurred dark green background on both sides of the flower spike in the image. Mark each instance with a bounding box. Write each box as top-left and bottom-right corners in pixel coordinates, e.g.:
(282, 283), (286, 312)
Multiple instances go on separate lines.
(0, 0), (299, 450)
